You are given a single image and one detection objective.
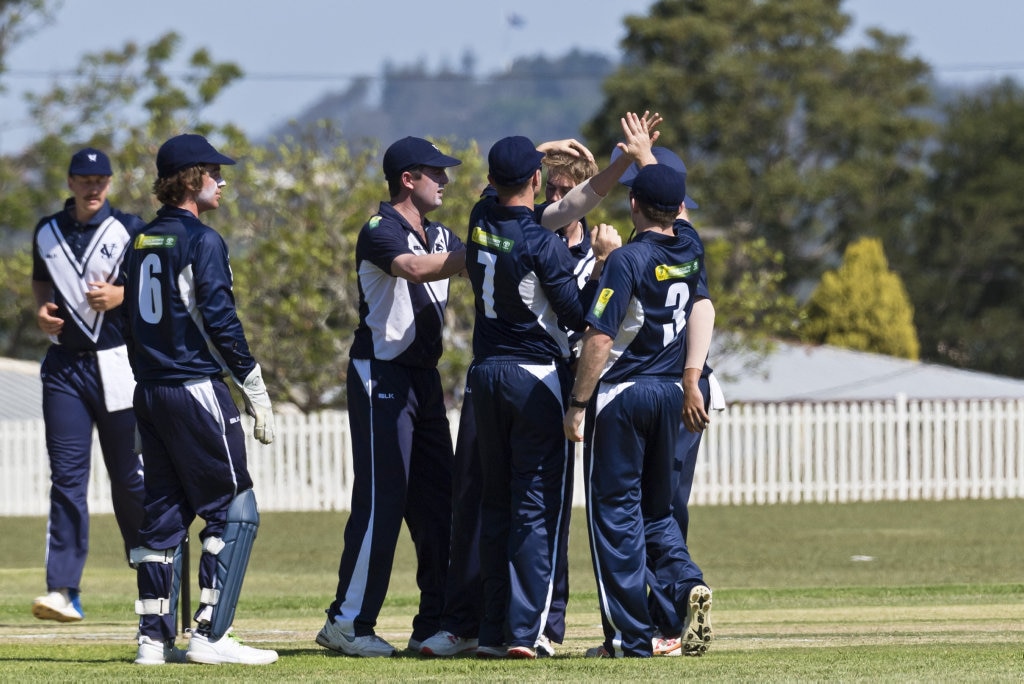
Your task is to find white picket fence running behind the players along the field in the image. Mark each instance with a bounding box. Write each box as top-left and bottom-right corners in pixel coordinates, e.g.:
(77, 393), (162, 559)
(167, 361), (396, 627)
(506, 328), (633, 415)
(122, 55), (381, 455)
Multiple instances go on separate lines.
(0, 397), (1024, 515)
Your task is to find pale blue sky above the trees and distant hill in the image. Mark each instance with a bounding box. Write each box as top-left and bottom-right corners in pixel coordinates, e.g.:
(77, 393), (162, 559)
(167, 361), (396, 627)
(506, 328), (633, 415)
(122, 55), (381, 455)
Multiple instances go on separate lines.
(0, 0), (1024, 153)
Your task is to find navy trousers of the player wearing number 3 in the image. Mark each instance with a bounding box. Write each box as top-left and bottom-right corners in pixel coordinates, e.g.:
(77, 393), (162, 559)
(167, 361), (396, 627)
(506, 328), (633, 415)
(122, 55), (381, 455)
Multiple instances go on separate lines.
(584, 377), (701, 656)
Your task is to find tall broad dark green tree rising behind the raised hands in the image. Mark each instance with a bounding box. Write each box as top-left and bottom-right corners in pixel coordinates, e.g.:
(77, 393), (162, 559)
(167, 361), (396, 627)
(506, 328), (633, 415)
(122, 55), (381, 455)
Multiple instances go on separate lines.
(584, 0), (933, 291)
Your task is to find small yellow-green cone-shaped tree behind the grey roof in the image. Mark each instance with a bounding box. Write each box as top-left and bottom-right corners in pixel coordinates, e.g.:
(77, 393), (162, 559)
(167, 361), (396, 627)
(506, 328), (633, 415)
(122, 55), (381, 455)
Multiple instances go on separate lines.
(800, 238), (920, 359)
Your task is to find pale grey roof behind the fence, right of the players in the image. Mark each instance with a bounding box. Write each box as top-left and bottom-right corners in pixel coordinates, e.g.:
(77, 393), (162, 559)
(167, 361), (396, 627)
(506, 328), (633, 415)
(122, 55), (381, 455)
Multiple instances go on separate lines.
(712, 342), (1024, 401)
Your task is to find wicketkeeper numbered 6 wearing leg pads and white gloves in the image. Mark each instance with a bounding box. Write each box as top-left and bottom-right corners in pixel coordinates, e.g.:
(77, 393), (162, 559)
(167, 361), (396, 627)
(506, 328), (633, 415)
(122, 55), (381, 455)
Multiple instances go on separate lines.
(124, 133), (278, 665)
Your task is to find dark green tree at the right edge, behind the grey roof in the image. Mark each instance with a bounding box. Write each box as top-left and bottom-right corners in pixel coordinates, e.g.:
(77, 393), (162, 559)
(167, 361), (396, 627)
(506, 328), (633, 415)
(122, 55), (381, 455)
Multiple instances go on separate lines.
(894, 79), (1024, 378)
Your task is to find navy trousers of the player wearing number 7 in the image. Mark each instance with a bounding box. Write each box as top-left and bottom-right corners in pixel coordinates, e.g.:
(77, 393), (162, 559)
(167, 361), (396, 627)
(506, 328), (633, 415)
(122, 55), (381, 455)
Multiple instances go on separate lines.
(470, 357), (572, 648)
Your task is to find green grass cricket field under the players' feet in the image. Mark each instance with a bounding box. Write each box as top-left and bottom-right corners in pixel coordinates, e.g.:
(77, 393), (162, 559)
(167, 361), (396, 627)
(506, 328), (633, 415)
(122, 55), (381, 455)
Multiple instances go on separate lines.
(0, 499), (1024, 682)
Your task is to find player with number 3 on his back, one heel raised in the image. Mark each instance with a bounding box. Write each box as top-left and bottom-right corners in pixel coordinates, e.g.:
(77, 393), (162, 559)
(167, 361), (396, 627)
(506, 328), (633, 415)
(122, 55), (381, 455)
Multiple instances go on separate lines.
(563, 164), (714, 657)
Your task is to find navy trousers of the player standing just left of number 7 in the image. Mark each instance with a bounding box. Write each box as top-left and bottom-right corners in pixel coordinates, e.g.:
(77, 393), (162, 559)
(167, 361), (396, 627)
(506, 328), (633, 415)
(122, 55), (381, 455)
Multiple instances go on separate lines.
(327, 358), (453, 641)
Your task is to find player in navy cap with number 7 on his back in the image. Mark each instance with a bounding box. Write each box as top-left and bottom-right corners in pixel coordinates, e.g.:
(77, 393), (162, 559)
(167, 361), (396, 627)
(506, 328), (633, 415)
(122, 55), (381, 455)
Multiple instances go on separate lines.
(466, 113), (651, 659)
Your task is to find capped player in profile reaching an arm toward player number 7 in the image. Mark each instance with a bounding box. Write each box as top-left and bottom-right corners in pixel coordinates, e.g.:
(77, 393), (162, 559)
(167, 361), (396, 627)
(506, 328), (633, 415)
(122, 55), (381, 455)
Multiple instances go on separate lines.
(316, 136), (466, 657)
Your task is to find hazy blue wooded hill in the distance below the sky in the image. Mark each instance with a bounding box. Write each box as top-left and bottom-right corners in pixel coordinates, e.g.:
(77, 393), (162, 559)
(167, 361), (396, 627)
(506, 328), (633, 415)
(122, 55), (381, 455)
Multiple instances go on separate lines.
(269, 50), (616, 149)
